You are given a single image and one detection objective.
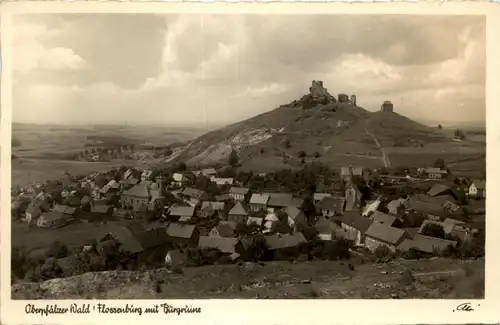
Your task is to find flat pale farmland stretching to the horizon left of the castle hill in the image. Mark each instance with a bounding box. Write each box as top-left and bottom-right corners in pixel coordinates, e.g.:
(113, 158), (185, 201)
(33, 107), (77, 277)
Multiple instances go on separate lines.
(12, 124), (206, 185)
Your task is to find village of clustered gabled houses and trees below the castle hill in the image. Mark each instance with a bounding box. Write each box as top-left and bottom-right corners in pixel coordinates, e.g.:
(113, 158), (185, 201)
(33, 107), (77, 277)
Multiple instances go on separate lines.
(12, 152), (486, 281)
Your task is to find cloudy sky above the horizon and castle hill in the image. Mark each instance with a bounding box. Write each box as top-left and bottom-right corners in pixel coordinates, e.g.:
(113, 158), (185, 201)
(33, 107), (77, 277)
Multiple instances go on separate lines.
(12, 14), (486, 126)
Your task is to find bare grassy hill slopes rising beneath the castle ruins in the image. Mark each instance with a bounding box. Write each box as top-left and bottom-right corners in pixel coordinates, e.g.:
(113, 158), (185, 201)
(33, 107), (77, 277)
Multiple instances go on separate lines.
(166, 83), (462, 171)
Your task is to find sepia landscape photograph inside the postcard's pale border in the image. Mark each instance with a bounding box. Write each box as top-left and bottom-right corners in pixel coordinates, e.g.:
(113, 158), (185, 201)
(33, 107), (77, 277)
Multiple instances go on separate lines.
(2, 2), (487, 306)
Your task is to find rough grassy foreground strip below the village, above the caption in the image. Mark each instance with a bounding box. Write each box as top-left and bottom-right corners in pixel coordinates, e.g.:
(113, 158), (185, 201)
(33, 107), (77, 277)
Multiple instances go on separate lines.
(12, 258), (484, 299)
